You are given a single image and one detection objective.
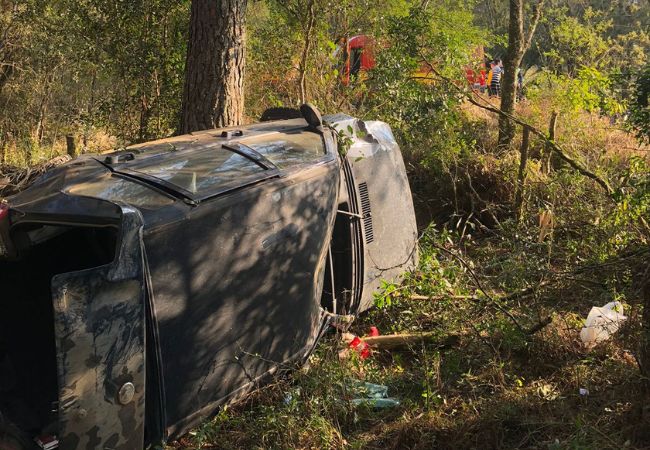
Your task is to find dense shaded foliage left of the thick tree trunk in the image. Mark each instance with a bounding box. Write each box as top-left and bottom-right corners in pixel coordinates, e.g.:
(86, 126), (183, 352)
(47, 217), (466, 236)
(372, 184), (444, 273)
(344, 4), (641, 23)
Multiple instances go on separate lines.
(0, 0), (189, 163)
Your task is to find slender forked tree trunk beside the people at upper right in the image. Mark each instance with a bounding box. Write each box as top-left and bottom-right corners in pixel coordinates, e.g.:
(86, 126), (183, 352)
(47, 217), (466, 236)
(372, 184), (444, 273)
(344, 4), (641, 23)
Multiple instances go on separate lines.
(499, 0), (544, 148)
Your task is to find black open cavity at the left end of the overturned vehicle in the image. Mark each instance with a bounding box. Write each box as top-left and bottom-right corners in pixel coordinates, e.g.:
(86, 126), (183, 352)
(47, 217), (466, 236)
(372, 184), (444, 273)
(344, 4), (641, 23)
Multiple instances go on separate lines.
(0, 224), (116, 450)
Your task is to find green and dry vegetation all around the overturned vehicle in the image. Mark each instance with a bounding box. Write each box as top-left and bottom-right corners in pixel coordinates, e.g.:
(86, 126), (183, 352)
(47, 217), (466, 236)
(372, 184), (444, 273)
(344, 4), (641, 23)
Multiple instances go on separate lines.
(0, 0), (650, 449)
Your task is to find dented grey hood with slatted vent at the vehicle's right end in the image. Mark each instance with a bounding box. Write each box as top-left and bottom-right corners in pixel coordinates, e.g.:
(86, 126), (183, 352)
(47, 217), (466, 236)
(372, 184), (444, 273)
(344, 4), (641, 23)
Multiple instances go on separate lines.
(324, 114), (418, 311)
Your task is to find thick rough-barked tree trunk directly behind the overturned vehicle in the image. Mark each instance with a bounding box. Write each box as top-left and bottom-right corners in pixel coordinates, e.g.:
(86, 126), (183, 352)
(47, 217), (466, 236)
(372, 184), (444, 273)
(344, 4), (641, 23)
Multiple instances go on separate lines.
(181, 0), (247, 133)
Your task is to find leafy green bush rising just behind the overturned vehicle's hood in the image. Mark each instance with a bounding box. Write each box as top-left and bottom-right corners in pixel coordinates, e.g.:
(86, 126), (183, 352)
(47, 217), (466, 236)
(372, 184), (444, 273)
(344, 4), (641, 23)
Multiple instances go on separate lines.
(364, 2), (483, 174)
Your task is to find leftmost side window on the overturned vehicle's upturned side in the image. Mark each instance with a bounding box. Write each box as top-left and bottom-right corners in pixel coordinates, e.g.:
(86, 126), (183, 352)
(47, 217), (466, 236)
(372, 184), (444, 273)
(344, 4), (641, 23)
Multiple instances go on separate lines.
(66, 176), (174, 209)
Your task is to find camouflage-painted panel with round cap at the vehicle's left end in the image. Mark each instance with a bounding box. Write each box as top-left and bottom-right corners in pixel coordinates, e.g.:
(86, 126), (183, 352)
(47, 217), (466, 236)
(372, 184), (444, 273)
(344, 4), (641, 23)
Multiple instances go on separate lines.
(52, 207), (145, 450)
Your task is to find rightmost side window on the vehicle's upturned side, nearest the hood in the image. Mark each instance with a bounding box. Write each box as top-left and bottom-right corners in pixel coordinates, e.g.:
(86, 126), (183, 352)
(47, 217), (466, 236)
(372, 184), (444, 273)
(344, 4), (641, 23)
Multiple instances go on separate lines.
(240, 131), (326, 169)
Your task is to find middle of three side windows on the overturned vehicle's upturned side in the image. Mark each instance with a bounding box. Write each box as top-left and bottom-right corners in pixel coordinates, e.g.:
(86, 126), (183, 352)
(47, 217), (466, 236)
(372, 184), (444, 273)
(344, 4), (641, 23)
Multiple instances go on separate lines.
(128, 145), (266, 194)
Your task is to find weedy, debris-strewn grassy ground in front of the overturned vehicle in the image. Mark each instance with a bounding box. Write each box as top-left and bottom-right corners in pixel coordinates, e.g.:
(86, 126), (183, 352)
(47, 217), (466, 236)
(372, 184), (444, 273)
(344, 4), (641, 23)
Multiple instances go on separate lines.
(168, 225), (650, 449)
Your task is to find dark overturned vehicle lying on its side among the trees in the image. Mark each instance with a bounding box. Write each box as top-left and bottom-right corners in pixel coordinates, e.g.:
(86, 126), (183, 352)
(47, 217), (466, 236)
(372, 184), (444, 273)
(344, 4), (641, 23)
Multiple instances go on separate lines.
(0, 107), (417, 450)
